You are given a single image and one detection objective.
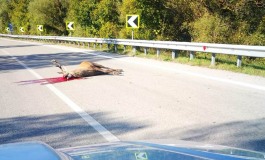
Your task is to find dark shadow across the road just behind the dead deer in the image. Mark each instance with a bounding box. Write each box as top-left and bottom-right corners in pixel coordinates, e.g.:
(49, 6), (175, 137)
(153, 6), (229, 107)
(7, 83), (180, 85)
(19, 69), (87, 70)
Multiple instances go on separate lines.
(0, 48), (125, 73)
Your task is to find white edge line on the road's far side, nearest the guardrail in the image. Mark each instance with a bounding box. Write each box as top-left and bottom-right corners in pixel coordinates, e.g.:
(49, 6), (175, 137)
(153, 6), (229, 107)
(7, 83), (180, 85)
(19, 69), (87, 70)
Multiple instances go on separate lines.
(49, 45), (265, 91)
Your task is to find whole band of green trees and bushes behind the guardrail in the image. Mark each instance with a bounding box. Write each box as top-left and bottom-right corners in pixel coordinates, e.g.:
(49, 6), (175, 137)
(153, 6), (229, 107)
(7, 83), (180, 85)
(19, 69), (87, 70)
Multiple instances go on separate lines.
(0, 0), (265, 45)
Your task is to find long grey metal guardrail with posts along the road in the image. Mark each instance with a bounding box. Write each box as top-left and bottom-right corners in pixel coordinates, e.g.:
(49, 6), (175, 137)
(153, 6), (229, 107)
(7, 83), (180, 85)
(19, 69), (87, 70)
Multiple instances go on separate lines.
(0, 34), (265, 67)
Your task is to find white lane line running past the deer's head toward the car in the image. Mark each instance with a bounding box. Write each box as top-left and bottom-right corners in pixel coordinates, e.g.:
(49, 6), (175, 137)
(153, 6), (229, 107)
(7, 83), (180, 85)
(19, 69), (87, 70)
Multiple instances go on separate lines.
(2, 49), (120, 142)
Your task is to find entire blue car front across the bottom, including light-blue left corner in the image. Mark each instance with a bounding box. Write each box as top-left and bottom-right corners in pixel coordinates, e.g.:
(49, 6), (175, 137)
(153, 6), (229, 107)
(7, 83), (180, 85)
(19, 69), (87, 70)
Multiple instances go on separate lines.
(0, 140), (265, 160)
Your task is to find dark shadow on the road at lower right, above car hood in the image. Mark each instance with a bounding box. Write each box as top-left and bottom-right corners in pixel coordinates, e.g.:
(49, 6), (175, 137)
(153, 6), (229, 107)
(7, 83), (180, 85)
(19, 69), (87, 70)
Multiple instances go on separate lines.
(152, 118), (265, 152)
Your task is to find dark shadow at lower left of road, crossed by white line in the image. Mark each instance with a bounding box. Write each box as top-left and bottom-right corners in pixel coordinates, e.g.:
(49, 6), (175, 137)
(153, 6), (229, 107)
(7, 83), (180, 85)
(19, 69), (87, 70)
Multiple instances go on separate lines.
(0, 113), (148, 148)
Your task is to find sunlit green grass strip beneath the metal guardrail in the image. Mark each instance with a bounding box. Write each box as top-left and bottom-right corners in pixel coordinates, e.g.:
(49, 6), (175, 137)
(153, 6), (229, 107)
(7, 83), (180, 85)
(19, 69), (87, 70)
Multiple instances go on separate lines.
(120, 49), (265, 77)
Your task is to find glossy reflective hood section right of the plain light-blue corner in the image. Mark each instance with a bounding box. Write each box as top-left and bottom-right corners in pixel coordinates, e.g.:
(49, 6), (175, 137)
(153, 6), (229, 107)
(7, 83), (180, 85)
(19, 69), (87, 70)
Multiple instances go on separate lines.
(59, 140), (265, 160)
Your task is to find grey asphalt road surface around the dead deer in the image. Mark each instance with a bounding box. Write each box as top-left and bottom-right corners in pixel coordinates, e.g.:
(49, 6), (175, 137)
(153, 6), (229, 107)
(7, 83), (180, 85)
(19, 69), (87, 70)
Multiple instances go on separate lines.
(0, 38), (265, 151)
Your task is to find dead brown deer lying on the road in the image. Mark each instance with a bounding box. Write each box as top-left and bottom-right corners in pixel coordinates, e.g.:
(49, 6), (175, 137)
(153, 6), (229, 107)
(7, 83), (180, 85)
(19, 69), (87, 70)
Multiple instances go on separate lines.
(52, 59), (123, 79)
